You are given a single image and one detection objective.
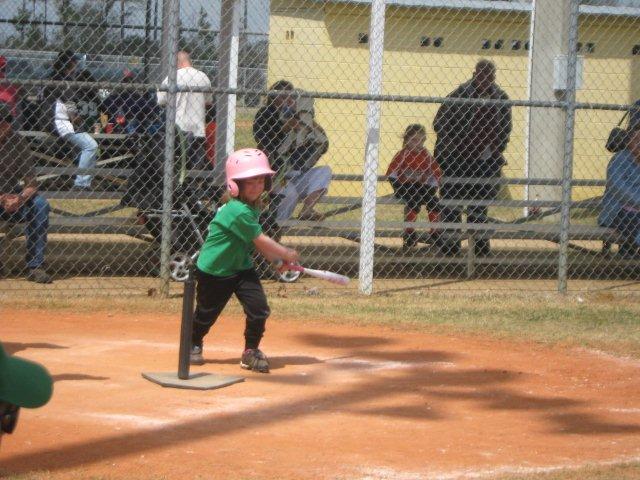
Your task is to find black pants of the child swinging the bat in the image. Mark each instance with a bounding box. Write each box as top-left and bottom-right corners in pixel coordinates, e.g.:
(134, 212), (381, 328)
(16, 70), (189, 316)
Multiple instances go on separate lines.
(192, 268), (271, 349)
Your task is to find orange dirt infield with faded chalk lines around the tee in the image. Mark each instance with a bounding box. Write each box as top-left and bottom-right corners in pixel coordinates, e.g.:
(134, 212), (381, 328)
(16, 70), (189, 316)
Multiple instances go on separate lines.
(0, 309), (640, 480)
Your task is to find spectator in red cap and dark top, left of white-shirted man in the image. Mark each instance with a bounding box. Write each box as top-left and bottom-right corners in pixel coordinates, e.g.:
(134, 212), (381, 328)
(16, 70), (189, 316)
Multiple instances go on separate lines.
(100, 68), (152, 135)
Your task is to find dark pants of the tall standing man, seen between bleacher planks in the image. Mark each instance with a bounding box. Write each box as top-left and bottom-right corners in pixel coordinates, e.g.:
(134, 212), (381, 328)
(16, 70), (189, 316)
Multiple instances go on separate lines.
(440, 183), (498, 255)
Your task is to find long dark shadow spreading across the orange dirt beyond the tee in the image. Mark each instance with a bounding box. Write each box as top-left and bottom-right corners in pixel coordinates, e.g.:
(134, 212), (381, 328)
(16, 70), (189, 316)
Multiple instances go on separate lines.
(4, 333), (640, 474)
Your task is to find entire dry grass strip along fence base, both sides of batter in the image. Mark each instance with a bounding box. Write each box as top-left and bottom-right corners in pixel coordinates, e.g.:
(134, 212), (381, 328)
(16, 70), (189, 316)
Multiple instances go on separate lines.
(8, 282), (640, 358)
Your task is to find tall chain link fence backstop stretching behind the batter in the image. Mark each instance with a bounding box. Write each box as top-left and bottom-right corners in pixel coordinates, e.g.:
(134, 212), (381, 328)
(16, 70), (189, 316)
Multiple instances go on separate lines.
(0, 0), (640, 294)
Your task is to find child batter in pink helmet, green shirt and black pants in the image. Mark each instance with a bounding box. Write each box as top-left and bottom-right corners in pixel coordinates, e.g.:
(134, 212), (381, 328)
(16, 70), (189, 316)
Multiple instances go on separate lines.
(190, 148), (298, 373)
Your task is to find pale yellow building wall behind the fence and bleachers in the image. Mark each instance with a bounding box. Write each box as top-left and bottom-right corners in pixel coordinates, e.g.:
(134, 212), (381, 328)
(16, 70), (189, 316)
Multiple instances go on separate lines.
(268, 0), (640, 197)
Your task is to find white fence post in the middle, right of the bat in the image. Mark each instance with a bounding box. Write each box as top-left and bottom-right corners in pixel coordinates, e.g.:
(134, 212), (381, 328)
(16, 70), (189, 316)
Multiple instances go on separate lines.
(359, 0), (385, 295)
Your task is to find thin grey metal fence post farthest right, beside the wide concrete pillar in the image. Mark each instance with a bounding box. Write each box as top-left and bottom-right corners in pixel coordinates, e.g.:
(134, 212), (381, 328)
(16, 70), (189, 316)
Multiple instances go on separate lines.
(558, 0), (580, 293)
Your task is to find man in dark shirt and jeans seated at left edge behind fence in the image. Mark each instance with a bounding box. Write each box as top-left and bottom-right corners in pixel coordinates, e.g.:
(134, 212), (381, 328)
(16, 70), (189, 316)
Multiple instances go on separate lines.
(0, 101), (51, 283)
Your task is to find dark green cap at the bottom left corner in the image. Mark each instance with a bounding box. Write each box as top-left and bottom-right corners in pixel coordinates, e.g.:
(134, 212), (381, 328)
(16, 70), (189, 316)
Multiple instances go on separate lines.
(0, 345), (53, 408)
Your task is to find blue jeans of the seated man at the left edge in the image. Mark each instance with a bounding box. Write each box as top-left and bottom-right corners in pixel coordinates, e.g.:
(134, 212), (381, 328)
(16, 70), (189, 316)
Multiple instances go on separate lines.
(0, 195), (50, 268)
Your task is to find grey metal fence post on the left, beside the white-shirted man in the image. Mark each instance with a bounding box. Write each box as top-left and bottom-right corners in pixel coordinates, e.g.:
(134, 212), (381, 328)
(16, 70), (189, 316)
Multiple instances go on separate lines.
(160, 0), (180, 298)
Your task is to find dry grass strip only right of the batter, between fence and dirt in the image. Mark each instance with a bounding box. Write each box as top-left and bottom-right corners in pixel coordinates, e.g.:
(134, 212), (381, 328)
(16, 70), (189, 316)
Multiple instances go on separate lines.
(271, 291), (640, 358)
